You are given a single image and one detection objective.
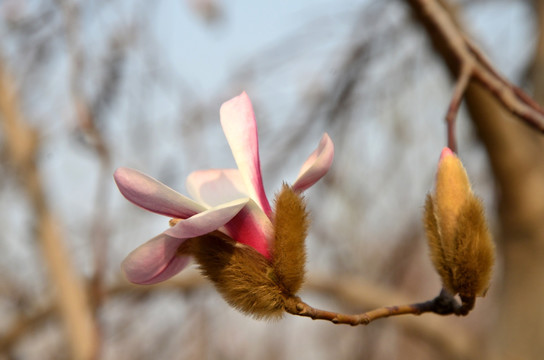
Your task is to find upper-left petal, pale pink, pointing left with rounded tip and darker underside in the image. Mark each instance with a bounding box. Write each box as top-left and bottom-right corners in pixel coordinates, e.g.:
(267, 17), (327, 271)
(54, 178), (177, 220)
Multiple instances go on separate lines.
(113, 167), (205, 219)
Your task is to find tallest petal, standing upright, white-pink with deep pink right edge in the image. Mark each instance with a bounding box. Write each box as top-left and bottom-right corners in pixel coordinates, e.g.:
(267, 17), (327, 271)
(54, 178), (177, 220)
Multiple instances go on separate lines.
(220, 92), (272, 216)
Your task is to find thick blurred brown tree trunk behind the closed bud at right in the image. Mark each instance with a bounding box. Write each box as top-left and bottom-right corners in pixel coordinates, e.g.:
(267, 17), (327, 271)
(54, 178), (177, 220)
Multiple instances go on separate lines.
(407, 0), (544, 360)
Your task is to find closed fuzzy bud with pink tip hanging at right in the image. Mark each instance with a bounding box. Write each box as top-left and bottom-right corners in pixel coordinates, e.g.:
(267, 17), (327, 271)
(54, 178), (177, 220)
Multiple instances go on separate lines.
(423, 148), (495, 298)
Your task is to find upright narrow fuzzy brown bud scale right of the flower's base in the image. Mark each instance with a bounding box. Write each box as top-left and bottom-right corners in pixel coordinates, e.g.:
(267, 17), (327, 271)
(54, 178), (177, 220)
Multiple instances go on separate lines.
(272, 184), (309, 295)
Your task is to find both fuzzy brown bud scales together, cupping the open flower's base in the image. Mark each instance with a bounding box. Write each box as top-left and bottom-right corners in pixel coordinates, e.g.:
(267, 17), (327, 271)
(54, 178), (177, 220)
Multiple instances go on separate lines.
(184, 185), (308, 319)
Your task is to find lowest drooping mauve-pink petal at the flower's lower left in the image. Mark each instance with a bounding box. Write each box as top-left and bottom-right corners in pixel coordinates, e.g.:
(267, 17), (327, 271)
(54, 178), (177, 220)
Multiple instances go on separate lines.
(121, 233), (190, 284)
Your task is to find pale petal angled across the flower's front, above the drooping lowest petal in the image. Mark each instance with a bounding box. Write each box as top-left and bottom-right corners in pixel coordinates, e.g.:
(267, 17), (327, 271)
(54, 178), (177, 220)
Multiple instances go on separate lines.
(164, 198), (251, 239)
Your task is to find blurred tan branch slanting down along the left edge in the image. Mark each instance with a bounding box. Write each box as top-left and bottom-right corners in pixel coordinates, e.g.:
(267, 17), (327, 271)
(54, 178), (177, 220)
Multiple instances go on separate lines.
(0, 57), (97, 360)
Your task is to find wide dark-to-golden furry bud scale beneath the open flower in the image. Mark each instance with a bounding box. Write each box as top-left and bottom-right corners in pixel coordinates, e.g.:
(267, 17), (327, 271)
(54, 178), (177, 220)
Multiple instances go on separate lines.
(185, 231), (284, 319)
